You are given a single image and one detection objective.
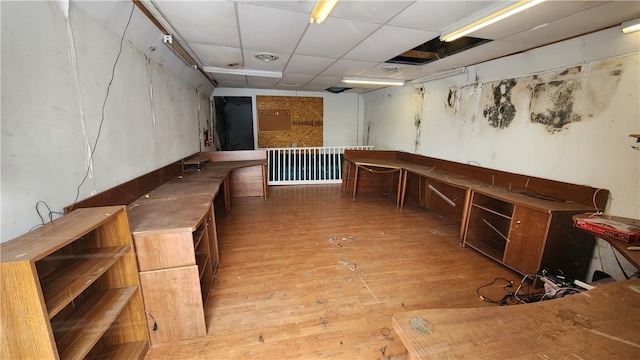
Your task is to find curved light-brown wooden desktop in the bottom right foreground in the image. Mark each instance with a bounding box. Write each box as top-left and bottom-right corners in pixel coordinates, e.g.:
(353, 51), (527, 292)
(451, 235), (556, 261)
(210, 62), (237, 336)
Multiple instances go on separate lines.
(393, 280), (640, 359)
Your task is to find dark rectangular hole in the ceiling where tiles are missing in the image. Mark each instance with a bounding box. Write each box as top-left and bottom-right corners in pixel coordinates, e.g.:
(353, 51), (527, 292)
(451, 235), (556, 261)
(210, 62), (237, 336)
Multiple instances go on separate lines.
(386, 37), (491, 65)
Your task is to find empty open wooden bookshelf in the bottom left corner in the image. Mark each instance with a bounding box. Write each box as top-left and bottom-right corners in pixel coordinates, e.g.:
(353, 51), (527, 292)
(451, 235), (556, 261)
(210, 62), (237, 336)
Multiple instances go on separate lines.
(0, 206), (149, 359)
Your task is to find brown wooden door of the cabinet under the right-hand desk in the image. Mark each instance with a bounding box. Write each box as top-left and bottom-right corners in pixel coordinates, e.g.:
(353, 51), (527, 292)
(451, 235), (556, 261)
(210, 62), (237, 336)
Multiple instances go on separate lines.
(504, 205), (550, 274)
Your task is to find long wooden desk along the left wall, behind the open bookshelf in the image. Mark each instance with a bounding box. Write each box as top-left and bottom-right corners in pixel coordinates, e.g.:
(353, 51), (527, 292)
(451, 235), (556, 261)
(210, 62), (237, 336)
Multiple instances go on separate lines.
(122, 152), (267, 345)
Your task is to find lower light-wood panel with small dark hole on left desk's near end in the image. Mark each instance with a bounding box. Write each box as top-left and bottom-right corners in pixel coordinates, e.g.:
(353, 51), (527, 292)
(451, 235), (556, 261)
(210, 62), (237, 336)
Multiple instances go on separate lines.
(140, 265), (207, 345)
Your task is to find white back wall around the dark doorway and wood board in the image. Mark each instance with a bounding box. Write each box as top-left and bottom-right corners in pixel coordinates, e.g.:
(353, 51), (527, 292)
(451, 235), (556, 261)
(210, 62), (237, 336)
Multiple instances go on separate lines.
(212, 88), (364, 148)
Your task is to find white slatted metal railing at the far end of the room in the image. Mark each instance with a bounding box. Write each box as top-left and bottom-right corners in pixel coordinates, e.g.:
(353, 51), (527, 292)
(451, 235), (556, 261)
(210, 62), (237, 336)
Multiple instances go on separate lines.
(266, 145), (373, 185)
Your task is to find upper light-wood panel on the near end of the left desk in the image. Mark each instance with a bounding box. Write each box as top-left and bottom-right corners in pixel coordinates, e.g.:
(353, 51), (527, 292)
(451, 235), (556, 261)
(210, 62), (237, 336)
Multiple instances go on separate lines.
(133, 231), (196, 271)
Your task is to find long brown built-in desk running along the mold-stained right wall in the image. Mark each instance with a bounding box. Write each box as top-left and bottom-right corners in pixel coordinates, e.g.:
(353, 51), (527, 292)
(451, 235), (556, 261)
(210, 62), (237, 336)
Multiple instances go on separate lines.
(343, 151), (606, 281)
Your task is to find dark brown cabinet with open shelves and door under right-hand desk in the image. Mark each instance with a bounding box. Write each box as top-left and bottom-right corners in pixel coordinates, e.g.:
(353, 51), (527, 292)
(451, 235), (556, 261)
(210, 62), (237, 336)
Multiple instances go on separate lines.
(464, 189), (595, 280)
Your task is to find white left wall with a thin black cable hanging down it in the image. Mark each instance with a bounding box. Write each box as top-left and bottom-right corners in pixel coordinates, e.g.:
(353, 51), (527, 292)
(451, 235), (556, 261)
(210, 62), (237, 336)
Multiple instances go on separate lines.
(0, 1), (213, 241)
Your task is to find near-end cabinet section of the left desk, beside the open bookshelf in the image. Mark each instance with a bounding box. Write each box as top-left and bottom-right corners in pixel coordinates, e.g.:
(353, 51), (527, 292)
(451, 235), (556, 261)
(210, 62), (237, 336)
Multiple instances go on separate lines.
(129, 195), (219, 346)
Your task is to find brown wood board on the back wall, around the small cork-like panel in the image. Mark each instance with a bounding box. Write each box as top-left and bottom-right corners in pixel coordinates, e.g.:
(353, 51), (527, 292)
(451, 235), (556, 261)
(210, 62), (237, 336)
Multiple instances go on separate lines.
(256, 96), (324, 148)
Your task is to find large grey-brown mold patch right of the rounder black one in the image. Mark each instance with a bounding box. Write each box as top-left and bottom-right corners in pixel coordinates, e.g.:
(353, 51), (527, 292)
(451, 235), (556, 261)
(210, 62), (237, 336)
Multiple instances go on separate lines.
(529, 66), (582, 133)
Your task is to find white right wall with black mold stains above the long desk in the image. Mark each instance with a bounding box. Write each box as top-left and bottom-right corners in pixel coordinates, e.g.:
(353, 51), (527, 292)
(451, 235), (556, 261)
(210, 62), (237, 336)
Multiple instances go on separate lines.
(363, 29), (640, 278)
